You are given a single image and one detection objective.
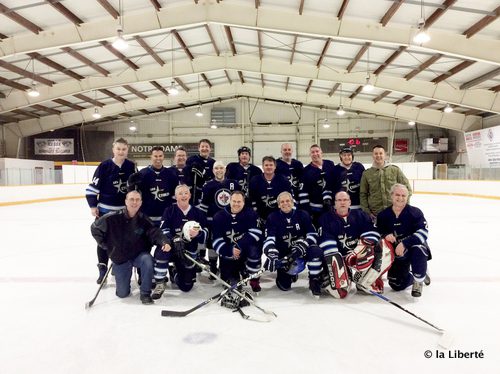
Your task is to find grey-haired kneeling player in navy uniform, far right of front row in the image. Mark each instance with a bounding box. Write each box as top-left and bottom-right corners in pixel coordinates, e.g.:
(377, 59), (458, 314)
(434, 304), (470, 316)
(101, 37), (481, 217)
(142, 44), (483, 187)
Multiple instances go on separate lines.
(377, 183), (431, 297)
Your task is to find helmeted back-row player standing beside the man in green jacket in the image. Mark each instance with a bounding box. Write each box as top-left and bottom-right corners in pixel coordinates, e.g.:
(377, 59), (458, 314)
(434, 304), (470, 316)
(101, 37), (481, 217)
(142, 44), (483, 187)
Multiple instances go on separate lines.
(329, 147), (365, 209)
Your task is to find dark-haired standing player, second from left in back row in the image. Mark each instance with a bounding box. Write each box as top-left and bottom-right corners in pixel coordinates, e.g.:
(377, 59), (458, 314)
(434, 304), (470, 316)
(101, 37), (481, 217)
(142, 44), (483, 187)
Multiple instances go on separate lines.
(128, 147), (175, 227)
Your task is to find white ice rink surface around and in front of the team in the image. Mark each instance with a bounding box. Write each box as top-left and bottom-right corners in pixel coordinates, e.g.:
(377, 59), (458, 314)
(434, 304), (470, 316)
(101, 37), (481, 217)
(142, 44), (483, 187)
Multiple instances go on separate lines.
(0, 195), (500, 374)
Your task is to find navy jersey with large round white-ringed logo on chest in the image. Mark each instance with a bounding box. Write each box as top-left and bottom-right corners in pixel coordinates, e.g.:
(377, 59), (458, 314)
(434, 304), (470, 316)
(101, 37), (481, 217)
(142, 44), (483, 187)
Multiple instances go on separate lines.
(199, 179), (241, 222)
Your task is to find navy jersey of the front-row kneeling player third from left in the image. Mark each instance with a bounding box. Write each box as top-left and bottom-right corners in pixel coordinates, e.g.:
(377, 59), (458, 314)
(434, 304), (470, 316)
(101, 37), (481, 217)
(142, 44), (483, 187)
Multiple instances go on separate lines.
(212, 207), (262, 257)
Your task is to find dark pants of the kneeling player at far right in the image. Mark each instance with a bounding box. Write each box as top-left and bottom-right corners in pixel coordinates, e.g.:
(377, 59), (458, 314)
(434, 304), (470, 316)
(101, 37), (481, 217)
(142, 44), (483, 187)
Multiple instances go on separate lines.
(387, 245), (429, 291)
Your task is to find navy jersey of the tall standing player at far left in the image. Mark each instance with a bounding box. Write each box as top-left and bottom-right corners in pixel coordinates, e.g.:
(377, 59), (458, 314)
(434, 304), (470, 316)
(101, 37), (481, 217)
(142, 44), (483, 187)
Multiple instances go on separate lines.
(85, 159), (137, 213)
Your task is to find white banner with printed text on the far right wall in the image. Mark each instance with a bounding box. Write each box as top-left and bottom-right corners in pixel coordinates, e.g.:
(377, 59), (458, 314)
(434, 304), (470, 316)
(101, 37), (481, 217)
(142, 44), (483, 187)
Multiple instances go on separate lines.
(465, 126), (500, 168)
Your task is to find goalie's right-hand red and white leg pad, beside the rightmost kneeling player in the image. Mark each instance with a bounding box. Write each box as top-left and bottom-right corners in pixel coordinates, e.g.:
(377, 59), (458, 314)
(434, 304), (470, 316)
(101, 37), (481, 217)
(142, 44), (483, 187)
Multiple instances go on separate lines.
(351, 239), (394, 289)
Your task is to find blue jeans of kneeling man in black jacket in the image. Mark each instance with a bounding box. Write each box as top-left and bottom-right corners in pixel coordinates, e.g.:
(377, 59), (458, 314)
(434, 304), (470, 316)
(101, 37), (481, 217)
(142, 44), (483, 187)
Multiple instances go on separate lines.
(113, 252), (153, 297)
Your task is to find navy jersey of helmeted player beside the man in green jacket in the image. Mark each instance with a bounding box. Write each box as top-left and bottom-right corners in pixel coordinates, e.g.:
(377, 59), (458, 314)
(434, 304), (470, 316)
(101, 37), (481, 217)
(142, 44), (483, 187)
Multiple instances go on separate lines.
(327, 161), (365, 206)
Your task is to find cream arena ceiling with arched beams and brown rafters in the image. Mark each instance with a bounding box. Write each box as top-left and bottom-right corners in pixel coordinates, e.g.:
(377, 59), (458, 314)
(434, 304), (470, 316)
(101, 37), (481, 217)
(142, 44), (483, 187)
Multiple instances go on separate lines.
(0, 0), (500, 137)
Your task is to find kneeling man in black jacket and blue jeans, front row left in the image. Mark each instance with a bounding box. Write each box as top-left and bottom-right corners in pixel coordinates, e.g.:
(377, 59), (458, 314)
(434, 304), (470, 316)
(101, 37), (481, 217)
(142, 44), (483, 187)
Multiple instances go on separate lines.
(90, 191), (171, 304)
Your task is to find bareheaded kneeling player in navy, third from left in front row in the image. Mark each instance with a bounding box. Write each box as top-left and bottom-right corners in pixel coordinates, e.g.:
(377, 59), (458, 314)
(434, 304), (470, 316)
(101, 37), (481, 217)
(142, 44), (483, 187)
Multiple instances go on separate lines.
(213, 191), (262, 292)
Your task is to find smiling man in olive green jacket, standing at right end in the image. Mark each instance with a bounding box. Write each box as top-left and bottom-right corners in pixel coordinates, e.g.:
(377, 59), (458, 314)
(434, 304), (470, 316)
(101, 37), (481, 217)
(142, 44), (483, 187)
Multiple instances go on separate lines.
(359, 145), (411, 219)
